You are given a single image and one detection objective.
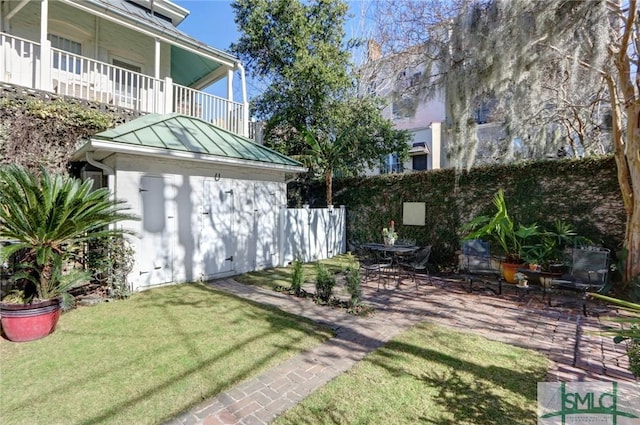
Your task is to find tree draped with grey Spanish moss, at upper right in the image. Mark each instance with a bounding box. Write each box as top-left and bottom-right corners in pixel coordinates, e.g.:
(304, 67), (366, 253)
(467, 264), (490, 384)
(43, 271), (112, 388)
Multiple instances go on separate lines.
(375, 0), (640, 280)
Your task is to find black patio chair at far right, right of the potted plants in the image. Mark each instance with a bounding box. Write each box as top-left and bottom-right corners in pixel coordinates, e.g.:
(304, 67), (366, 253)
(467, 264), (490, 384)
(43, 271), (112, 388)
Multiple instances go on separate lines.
(549, 247), (610, 316)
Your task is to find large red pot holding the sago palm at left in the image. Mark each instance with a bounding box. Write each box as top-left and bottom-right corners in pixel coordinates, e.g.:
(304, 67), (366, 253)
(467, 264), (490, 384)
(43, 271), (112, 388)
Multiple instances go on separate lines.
(0, 298), (62, 342)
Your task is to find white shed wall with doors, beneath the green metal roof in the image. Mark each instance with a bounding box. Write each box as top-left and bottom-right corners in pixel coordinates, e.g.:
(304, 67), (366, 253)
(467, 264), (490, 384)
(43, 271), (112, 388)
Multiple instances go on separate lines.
(106, 155), (286, 289)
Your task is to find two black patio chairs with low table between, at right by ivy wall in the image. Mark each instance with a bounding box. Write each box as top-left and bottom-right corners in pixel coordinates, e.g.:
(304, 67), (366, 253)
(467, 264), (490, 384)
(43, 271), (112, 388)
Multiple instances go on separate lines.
(459, 239), (610, 316)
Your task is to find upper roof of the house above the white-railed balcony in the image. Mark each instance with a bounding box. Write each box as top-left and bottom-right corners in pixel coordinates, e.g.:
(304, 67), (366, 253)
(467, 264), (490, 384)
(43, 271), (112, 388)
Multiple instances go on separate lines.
(65, 0), (239, 89)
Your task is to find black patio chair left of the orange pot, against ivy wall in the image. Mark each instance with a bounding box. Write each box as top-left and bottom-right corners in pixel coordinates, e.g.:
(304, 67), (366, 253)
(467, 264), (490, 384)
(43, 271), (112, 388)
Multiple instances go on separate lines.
(459, 239), (502, 295)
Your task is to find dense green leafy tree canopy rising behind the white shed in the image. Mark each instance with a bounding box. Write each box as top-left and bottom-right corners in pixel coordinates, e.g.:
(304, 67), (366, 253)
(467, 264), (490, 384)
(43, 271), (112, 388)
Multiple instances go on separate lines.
(231, 0), (408, 202)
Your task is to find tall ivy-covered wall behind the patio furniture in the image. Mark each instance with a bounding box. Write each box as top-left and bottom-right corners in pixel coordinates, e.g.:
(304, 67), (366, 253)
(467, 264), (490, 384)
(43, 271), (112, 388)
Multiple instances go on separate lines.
(289, 156), (625, 270)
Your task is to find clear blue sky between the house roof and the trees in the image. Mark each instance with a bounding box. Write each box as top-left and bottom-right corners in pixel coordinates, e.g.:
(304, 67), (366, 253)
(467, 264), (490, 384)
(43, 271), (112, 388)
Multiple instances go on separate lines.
(173, 0), (378, 100)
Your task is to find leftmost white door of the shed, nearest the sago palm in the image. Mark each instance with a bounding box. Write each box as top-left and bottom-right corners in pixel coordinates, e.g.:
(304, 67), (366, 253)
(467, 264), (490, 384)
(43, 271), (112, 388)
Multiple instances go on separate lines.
(137, 176), (176, 287)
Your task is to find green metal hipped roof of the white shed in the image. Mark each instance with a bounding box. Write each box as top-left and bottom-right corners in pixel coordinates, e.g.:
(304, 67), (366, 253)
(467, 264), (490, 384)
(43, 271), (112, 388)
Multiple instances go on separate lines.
(73, 114), (306, 172)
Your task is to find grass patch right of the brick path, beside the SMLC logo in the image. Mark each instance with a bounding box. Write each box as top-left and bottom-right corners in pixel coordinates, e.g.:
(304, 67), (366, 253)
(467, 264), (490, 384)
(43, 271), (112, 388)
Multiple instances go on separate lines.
(275, 323), (548, 425)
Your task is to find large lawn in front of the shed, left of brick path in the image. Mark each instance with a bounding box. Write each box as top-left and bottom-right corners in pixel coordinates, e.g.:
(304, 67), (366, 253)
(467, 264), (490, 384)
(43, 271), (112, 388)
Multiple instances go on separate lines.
(0, 284), (330, 425)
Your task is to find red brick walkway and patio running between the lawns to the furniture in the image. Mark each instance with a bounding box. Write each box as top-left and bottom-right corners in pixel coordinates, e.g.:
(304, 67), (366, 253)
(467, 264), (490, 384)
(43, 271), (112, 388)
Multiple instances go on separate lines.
(167, 277), (633, 425)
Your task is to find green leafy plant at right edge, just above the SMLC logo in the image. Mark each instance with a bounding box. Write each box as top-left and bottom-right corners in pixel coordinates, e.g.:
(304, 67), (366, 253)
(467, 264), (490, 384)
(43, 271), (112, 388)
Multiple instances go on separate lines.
(587, 293), (640, 378)
